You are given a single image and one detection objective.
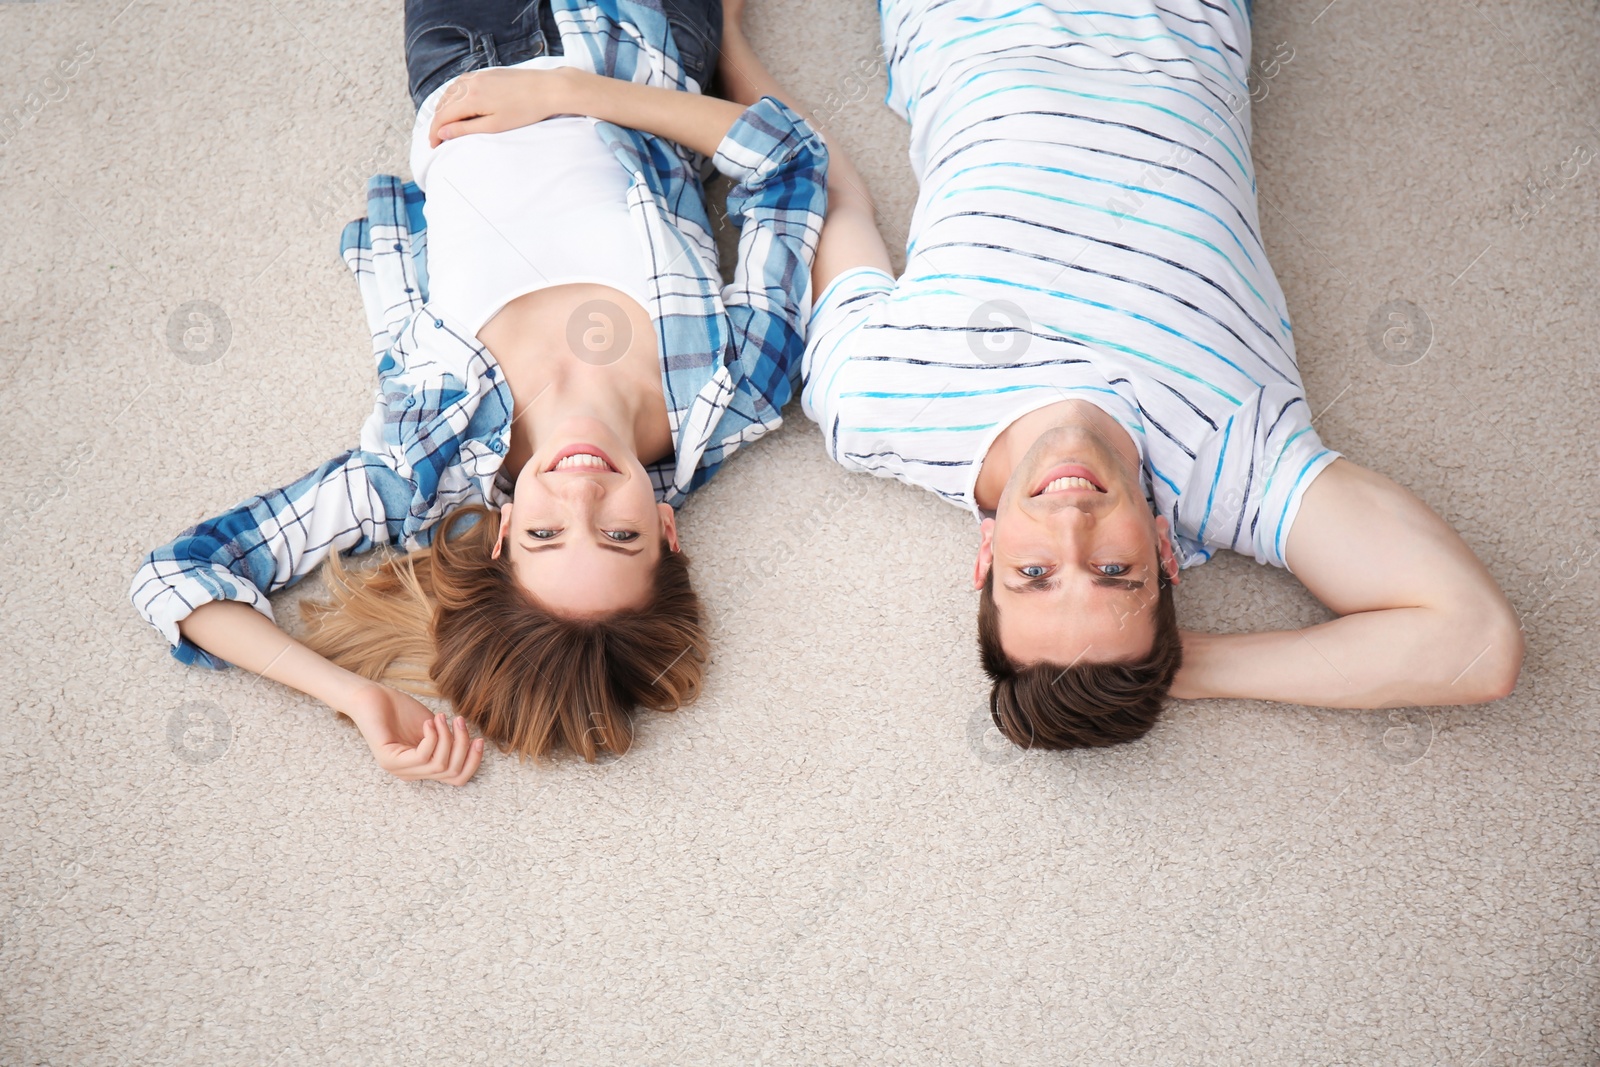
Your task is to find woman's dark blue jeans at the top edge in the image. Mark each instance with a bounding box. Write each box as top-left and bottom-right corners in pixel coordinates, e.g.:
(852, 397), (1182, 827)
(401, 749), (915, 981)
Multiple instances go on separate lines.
(405, 0), (722, 106)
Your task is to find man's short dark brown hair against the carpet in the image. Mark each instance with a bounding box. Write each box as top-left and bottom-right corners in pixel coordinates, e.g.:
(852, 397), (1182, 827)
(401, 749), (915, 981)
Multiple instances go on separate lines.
(978, 568), (1184, 749)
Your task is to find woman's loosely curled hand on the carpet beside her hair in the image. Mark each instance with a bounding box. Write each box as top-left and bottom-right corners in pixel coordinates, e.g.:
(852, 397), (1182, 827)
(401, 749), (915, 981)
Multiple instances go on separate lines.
(338, 681), (483, 785)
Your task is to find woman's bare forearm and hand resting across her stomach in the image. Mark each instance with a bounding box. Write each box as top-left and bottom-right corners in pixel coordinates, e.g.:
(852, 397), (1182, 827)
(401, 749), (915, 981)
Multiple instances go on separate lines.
(429, 67), (744, 155)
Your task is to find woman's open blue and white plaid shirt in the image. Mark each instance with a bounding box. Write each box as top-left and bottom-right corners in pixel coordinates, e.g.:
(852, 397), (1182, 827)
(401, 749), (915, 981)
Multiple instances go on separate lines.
(131, 0), (827, 667)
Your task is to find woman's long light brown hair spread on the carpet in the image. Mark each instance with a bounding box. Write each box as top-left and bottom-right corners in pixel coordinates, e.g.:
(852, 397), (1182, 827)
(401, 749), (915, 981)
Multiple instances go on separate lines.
(301, 506), (709, 760)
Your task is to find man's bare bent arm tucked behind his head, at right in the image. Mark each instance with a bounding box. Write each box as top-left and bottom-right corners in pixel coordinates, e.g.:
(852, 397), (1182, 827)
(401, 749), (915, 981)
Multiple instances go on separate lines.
(1171, 459), (1523, 707)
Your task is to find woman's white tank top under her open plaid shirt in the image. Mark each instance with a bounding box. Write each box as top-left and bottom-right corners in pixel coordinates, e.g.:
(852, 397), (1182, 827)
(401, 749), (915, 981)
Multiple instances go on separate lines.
(411, 56), (650, 336)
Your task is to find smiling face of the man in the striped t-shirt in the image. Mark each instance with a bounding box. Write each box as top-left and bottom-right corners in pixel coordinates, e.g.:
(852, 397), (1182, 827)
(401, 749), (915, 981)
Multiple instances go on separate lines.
(973, 426), (1178, 665)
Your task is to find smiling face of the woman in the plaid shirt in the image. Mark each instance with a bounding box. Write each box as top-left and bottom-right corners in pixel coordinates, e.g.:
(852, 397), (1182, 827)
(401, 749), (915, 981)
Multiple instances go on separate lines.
(501, 419), (678, 617)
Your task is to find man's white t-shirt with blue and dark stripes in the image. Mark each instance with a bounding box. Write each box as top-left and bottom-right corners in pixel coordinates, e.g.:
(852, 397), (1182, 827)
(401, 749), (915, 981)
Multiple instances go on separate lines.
(803, 0), (1336, 566)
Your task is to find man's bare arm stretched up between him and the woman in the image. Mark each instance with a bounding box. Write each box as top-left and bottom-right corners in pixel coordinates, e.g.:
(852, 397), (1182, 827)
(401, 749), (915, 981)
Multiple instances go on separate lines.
(718, 8), (890, 289)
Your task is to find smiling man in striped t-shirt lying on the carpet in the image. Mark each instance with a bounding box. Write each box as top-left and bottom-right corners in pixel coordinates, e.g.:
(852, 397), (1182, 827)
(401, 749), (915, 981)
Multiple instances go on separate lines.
(787, 0), (1523, 747)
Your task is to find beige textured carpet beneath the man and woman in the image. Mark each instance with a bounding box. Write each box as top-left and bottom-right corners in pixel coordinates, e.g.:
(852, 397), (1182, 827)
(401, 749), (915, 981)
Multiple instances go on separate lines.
(0, 0), (1600, 1067)
